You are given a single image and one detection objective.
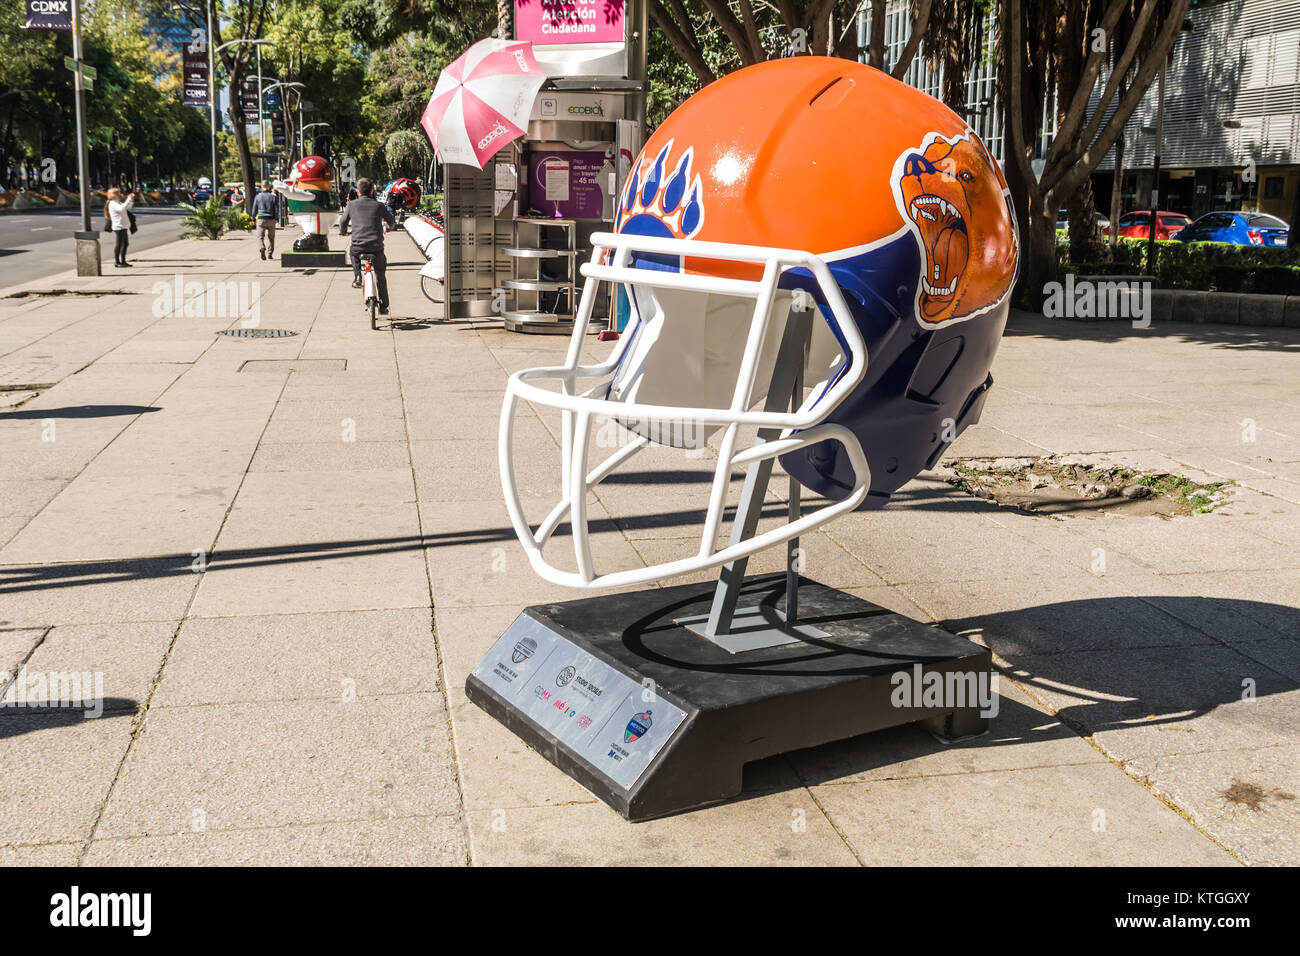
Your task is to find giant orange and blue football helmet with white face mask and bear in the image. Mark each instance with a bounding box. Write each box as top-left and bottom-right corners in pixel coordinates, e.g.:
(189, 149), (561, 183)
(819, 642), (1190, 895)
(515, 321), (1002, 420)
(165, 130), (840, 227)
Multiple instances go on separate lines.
(501, 57), (1018, 588)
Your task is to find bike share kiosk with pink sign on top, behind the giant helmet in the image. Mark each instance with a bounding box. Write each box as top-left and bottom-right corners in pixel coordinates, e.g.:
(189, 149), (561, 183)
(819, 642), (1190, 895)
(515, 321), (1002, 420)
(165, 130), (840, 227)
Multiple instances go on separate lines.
(442, 0), (646, 334)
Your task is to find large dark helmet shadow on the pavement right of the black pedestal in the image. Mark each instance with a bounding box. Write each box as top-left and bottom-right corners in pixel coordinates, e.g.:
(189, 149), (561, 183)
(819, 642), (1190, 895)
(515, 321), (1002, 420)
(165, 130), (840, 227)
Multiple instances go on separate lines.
(759, 596), (1300, 799)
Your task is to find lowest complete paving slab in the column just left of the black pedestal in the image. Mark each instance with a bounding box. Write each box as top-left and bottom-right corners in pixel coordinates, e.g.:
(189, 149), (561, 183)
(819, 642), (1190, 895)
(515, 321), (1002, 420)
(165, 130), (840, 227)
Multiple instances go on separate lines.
(95, 693), (460, 839)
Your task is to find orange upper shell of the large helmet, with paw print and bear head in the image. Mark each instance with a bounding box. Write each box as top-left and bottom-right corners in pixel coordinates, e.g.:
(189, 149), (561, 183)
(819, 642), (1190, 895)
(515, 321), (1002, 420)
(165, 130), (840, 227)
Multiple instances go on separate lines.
(615, 56), (1017, 328)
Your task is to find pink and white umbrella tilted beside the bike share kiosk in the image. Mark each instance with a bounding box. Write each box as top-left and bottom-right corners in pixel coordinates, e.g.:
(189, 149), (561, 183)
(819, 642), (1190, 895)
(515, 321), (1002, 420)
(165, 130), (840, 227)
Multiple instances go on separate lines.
(420, 38), (546, 169)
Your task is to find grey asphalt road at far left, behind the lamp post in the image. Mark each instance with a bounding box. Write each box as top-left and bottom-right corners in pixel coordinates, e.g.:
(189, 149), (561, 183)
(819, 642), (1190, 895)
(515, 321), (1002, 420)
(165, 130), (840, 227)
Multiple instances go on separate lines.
(0, 207), (183, 289)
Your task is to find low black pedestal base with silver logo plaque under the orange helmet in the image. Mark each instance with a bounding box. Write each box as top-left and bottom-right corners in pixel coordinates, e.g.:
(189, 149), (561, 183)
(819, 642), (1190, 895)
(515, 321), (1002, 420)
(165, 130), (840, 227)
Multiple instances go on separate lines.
(465, 575), (991, 821)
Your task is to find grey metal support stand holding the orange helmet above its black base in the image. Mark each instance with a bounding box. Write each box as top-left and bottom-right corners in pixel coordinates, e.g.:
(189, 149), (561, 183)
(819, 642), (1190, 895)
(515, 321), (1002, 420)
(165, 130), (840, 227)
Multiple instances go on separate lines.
(676, 310), (827, 654)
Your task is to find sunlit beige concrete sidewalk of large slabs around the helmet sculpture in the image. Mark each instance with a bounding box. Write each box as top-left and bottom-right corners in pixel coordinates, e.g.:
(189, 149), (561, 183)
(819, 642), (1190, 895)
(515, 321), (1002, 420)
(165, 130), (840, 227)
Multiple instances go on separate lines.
(0, 235), (1300, 865)
